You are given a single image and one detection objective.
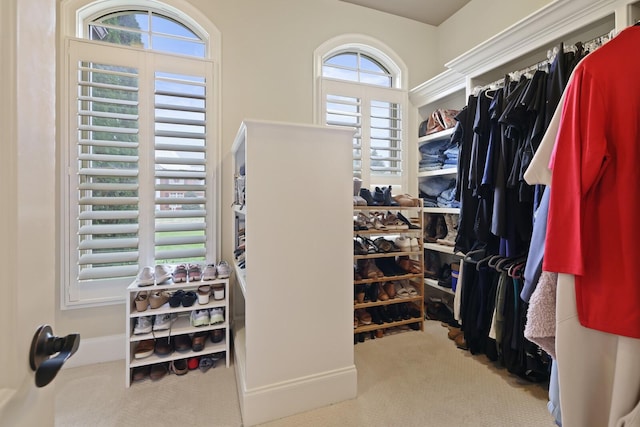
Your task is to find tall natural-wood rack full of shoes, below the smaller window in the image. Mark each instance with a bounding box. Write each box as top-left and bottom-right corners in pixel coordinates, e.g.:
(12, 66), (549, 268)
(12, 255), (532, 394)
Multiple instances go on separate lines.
(353, 203), (424, 342)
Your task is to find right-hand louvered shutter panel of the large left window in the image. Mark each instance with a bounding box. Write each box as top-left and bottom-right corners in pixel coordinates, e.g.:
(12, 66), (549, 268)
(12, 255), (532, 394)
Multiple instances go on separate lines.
(154, 68), (207, 263)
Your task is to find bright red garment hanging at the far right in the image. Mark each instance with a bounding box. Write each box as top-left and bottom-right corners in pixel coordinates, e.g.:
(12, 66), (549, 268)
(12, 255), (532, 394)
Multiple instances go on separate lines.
(543, 27), (640, 338)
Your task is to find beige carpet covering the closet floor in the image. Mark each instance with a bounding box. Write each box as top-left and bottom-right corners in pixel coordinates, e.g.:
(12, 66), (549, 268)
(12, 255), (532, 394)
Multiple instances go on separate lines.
(55, 321), (555, 427)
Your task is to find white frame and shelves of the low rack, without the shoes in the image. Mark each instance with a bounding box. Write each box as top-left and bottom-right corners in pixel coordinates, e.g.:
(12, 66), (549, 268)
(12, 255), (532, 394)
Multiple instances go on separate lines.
(125, 279), (231, 387)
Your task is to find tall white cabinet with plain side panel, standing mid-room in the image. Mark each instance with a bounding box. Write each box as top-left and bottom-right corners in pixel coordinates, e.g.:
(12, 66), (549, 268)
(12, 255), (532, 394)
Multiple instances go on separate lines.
(232, 120), (357, 425)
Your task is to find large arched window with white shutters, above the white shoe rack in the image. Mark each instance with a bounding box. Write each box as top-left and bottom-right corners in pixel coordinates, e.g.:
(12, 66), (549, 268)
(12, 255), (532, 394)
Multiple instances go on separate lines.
(61, 0), (220, 307)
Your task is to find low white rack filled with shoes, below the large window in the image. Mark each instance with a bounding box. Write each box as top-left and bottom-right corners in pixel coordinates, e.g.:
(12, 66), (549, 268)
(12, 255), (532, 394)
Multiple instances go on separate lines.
(125, 274), (231, 387)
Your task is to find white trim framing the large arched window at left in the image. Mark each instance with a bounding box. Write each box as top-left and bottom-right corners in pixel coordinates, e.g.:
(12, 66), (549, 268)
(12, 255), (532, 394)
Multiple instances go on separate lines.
(57, 0), (222, 310)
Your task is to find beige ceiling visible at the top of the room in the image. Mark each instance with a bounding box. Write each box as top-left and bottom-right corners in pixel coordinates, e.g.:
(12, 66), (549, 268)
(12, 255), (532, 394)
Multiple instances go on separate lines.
(341, 0), (471, 26)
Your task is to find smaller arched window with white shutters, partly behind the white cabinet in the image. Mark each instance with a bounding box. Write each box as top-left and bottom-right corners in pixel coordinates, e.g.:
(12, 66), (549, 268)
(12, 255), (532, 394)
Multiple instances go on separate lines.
(315, 35), (408, 191)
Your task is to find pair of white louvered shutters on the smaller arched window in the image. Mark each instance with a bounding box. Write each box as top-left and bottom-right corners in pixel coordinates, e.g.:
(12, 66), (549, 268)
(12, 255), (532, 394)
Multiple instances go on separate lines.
(322, 79), (406, 186)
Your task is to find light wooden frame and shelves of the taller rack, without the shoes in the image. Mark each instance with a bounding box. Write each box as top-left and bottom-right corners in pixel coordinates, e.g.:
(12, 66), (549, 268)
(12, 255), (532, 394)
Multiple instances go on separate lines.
(353, 199), (424, 341)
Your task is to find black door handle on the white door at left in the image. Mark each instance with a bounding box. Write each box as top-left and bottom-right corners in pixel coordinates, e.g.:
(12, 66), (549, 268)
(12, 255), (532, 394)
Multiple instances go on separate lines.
(29, 325), (80, 387)
